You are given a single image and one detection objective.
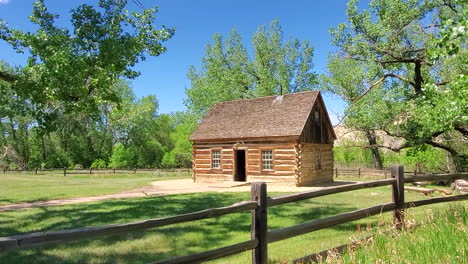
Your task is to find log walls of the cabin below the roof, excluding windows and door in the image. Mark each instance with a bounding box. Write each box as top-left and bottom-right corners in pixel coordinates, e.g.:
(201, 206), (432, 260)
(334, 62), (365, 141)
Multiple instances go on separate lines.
(193, 142), (333, 186)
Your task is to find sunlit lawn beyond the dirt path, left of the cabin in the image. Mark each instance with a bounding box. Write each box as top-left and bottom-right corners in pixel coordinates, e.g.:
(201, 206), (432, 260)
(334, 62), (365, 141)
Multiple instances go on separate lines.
(0, 173), (190, 205)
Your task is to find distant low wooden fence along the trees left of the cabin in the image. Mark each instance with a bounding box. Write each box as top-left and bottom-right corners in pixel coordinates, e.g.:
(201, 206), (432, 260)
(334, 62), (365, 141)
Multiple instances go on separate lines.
(0, 168), (192, 176)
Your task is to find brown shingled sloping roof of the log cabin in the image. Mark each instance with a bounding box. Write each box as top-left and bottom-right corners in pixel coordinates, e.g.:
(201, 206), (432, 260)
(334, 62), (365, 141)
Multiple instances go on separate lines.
(190, 91), (329, 141)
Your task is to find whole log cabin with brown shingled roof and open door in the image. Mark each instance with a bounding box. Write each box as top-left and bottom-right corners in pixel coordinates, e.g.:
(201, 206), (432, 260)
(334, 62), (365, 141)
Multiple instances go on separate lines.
(190, 91), (336, 186)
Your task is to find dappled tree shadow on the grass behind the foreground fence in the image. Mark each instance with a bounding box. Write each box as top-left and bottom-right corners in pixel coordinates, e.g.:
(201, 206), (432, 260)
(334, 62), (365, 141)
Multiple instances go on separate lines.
(0, 193), (376, 263)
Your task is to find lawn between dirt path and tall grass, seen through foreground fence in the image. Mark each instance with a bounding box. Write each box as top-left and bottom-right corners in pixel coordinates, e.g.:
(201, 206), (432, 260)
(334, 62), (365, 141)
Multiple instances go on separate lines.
(0, 186), (468, 263)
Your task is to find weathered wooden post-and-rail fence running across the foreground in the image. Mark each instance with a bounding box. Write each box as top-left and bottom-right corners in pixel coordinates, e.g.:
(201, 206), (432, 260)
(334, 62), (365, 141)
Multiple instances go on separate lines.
(0, 166), (468, 264)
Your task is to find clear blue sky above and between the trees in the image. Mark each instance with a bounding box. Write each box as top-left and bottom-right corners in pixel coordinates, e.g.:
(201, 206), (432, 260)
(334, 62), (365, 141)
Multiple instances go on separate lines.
(0, 0), (367, 122)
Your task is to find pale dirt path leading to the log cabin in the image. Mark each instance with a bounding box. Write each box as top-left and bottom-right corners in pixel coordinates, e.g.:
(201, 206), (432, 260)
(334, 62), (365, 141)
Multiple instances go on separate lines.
(0, 179), (352, 212)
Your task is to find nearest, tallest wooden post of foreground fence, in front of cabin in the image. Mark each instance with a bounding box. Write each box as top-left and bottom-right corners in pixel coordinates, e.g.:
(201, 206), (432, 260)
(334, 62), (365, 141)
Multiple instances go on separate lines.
(250, 182), (268, 264)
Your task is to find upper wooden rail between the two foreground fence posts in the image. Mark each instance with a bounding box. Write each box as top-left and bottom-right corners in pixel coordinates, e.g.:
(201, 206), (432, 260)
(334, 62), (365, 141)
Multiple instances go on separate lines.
(268, 179), (395, 206)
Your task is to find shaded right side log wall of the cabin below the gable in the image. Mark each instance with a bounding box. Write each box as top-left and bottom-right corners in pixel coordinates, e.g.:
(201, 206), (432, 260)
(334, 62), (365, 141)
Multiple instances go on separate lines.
(296, 143), (333, 186)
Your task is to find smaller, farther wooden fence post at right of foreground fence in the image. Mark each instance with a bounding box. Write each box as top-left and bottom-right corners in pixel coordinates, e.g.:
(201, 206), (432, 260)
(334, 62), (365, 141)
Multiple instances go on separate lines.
(390, 166), (405, 230)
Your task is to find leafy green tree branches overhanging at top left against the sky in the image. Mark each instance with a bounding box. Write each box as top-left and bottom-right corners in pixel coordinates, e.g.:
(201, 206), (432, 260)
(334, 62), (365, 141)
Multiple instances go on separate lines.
(0, 0), (174, 128)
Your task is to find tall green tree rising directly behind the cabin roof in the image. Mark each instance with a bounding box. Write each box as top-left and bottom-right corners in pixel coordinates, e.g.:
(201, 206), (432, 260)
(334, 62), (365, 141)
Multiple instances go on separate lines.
(186, 20), (317, 114)
